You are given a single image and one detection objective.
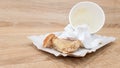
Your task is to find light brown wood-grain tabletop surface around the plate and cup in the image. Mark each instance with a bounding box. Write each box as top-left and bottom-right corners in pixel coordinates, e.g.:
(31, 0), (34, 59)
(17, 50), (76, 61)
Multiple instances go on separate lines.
(0, 0), (120, 68)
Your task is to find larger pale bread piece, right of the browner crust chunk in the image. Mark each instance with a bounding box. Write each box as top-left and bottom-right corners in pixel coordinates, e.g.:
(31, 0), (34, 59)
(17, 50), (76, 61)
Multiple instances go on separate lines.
(53, 38), (82, 53)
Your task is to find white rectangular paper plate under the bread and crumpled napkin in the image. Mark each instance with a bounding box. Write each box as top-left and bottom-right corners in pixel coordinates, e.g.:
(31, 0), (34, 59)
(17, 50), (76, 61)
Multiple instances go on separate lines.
(28, 32), (115, 57)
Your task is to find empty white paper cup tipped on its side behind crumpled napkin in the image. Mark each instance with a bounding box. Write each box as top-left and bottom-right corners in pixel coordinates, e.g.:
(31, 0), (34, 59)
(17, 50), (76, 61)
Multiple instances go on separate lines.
(69, 1), (105, 33)
